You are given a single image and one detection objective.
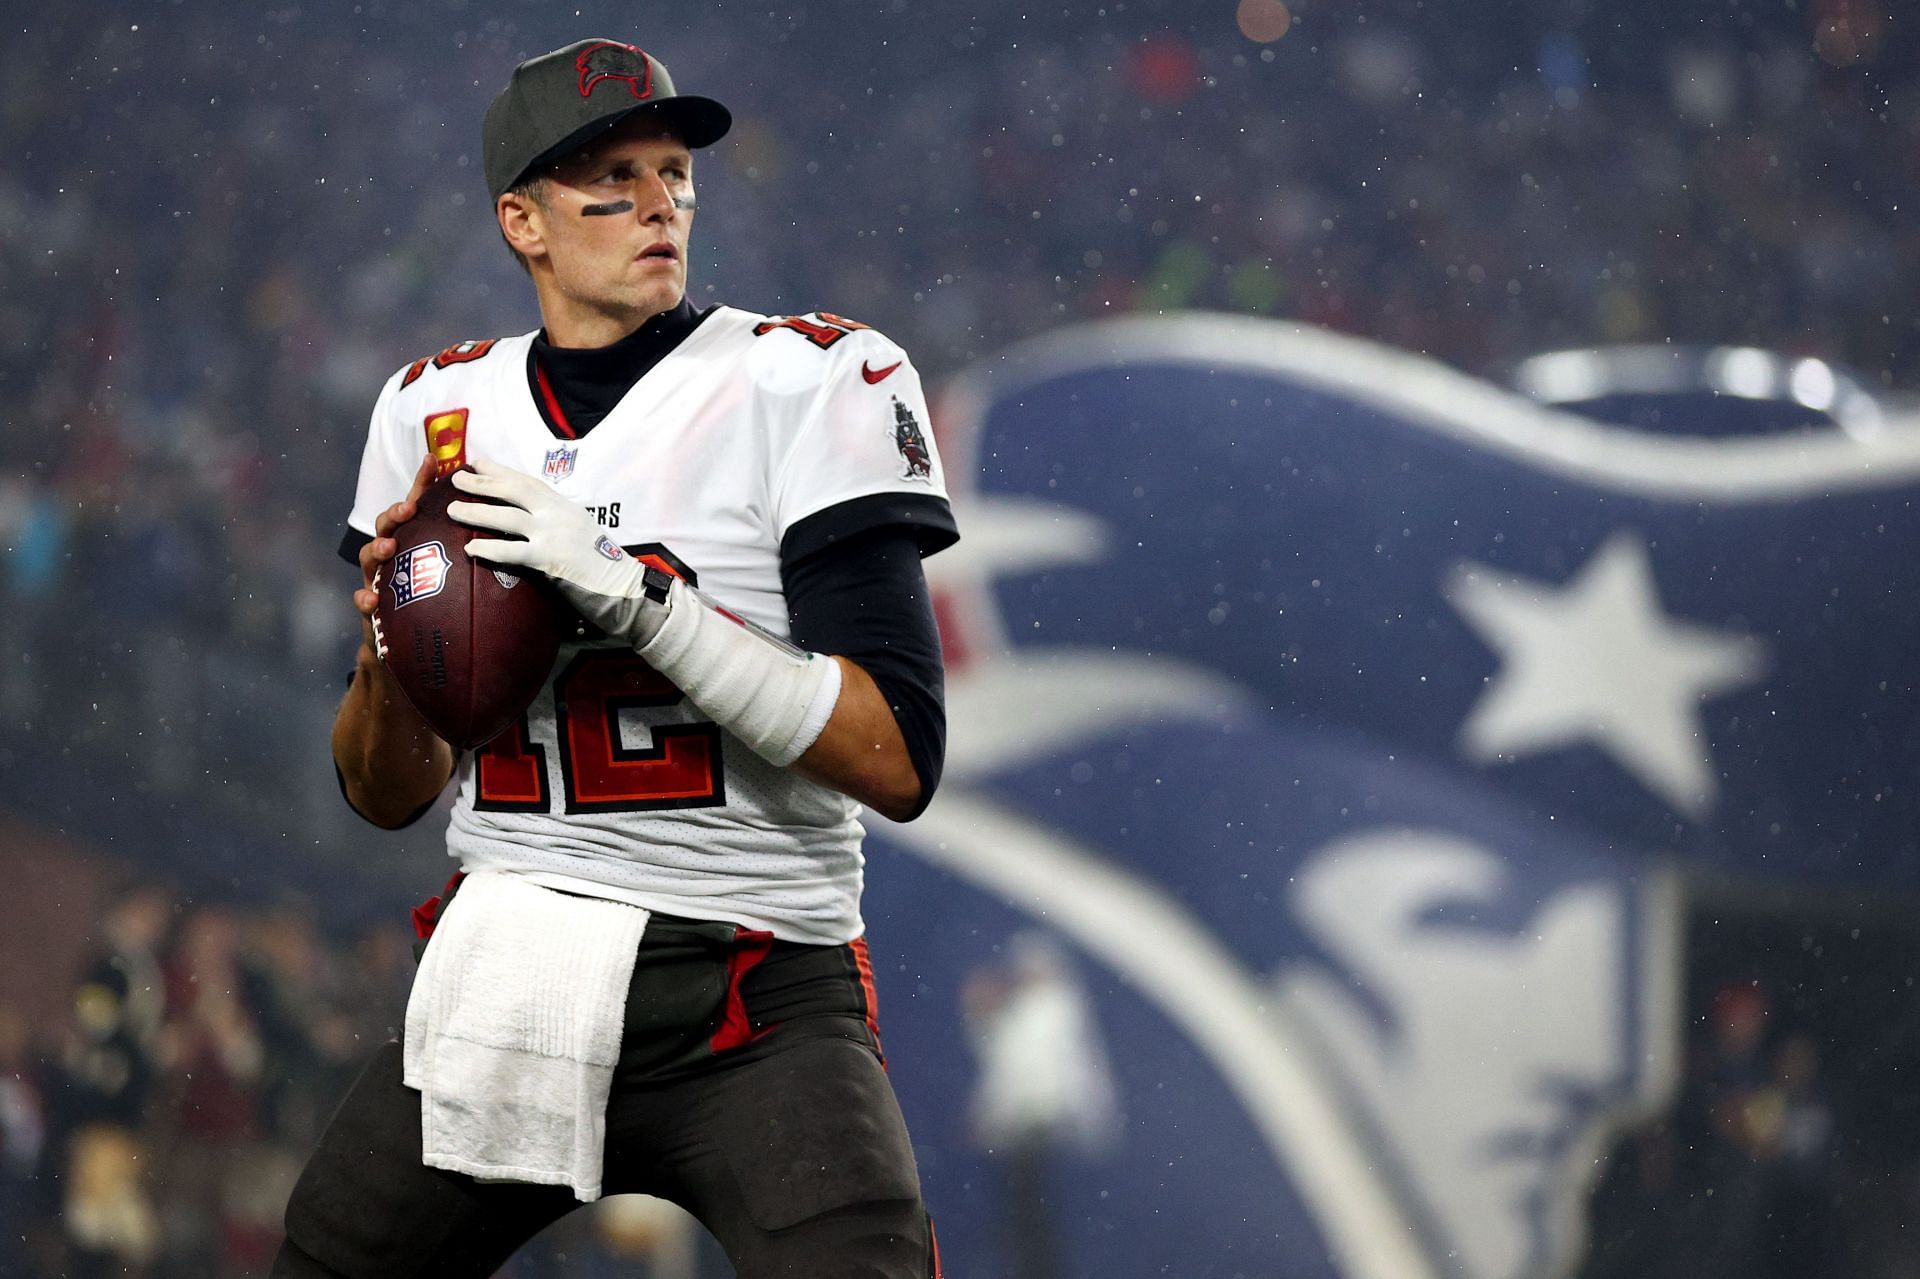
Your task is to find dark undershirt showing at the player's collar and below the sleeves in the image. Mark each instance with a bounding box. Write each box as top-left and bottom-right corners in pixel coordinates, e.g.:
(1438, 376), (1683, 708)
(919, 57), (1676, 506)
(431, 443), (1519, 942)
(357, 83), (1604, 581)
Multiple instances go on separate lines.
(340, 298), (958, 816)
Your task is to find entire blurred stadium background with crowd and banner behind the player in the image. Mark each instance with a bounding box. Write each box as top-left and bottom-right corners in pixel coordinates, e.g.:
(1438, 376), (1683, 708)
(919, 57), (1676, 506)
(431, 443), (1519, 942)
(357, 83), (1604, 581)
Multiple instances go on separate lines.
(0, 0), (1920, 1279)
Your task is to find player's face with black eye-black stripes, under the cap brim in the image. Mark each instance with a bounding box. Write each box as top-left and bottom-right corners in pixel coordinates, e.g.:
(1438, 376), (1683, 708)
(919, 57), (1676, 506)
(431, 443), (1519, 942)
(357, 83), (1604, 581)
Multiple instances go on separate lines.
(503, 115), (693, 334)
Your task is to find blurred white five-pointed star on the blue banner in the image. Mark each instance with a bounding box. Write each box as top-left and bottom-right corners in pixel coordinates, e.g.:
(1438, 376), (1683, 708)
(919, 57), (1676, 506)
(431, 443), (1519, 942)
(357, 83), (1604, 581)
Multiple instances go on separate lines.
(1444, 532), (1766, 820)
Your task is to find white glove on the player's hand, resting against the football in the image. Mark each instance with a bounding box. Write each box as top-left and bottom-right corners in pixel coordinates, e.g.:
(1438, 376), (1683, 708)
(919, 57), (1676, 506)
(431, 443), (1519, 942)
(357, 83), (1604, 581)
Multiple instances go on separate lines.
(447, 457), (670, 649)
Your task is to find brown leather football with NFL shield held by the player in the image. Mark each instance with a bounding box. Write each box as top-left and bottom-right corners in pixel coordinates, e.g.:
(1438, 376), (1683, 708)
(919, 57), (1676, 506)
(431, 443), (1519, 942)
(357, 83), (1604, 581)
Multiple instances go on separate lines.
(372, 476), (563, 749)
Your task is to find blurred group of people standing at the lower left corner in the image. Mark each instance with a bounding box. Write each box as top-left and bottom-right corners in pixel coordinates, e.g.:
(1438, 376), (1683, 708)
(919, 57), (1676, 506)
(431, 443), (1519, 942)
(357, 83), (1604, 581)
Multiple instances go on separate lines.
(0, 881), (413, 1279)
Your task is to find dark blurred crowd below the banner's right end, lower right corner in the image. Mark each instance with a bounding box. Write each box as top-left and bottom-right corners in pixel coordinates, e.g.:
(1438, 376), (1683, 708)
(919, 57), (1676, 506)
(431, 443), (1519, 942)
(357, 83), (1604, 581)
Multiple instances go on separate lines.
(1578, 891), (1920, 1279)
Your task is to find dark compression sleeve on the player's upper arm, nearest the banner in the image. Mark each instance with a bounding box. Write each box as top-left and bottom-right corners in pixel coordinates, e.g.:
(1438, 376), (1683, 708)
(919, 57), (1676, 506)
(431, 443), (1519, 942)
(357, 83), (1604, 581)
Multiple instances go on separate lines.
(780, 524), (947, 816)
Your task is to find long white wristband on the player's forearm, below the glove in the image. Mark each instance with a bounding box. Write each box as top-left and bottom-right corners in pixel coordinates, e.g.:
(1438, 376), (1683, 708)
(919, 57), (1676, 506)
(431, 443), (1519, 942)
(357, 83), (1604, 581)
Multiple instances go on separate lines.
(636, 578), (841, 768)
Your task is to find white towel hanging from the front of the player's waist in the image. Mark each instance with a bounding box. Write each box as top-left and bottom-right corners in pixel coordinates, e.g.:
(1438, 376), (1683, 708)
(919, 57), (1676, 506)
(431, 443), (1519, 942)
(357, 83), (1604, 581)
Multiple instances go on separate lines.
(403, 870), (647, 1204)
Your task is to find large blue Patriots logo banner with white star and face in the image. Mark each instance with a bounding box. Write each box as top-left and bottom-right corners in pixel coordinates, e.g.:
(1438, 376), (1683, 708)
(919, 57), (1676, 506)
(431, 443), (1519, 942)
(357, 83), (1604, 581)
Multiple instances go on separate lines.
(866, 315), (1920, 1279)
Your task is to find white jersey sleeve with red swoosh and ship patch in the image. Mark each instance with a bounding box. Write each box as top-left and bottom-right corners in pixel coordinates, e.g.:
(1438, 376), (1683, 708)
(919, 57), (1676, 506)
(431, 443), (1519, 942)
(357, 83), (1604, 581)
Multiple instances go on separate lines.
(772, 316), (952, 545)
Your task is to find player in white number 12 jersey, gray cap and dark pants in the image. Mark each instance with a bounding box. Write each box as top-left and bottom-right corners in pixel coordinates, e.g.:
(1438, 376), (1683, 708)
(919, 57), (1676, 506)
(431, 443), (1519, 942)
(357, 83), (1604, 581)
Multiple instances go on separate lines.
(273, 40), (956, 1279)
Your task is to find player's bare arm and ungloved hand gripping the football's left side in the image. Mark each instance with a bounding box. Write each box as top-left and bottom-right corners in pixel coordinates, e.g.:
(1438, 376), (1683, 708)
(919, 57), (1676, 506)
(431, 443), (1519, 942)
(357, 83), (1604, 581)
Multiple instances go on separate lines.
(334, 457), (453, 830)
